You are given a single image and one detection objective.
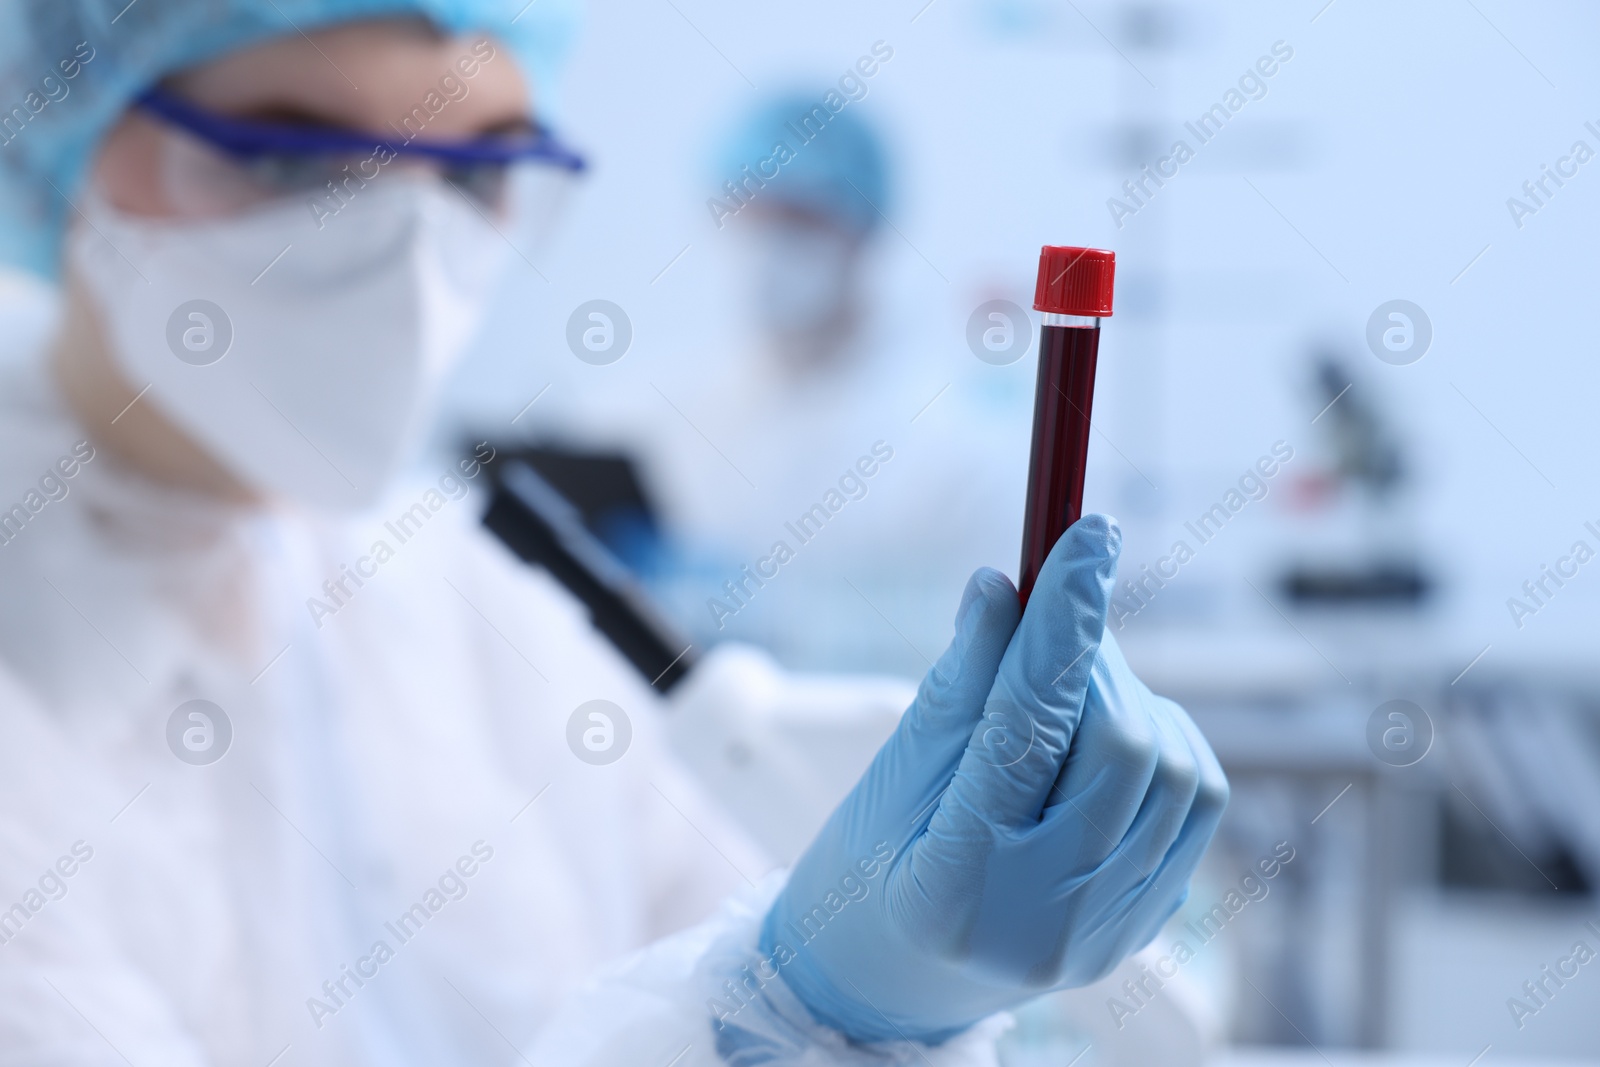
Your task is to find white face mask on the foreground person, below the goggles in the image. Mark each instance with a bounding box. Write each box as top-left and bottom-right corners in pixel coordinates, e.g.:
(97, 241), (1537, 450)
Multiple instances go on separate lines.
(67, 174), (507, 510)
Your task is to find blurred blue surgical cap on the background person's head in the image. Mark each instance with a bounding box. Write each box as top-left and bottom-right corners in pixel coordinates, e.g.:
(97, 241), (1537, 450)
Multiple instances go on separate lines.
(718, 93), (890, 234)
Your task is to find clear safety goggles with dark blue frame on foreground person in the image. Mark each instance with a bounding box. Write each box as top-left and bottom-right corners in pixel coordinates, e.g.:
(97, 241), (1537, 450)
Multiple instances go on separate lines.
(136, 88), (587, 227)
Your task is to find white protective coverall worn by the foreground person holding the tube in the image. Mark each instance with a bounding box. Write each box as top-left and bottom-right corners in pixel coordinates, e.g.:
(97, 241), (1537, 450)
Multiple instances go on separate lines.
(0, 321), (997, 1067)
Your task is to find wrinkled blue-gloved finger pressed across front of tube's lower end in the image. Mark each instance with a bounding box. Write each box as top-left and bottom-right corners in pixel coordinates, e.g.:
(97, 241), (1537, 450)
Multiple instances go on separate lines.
(934, 515), (1122, 829)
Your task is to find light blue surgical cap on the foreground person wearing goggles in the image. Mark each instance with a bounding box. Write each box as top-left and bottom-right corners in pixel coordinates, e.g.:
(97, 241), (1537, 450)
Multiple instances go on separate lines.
(0, 0), (578, 277)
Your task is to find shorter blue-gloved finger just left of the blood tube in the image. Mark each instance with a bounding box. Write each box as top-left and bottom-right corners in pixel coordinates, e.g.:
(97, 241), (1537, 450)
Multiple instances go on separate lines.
(856, 566), (1021, 838)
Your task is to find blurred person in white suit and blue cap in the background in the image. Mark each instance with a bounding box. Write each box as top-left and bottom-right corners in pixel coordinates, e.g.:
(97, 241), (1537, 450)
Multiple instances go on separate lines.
(595, 91), (1032, 672)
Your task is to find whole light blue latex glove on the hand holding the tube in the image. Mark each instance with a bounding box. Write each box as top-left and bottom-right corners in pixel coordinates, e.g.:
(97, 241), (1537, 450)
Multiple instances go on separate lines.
(762, 515), (1227, 1041)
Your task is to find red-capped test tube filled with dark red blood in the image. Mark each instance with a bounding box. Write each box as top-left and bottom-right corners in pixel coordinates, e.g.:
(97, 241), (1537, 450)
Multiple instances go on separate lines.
(1018, 245), (1117, 606)
